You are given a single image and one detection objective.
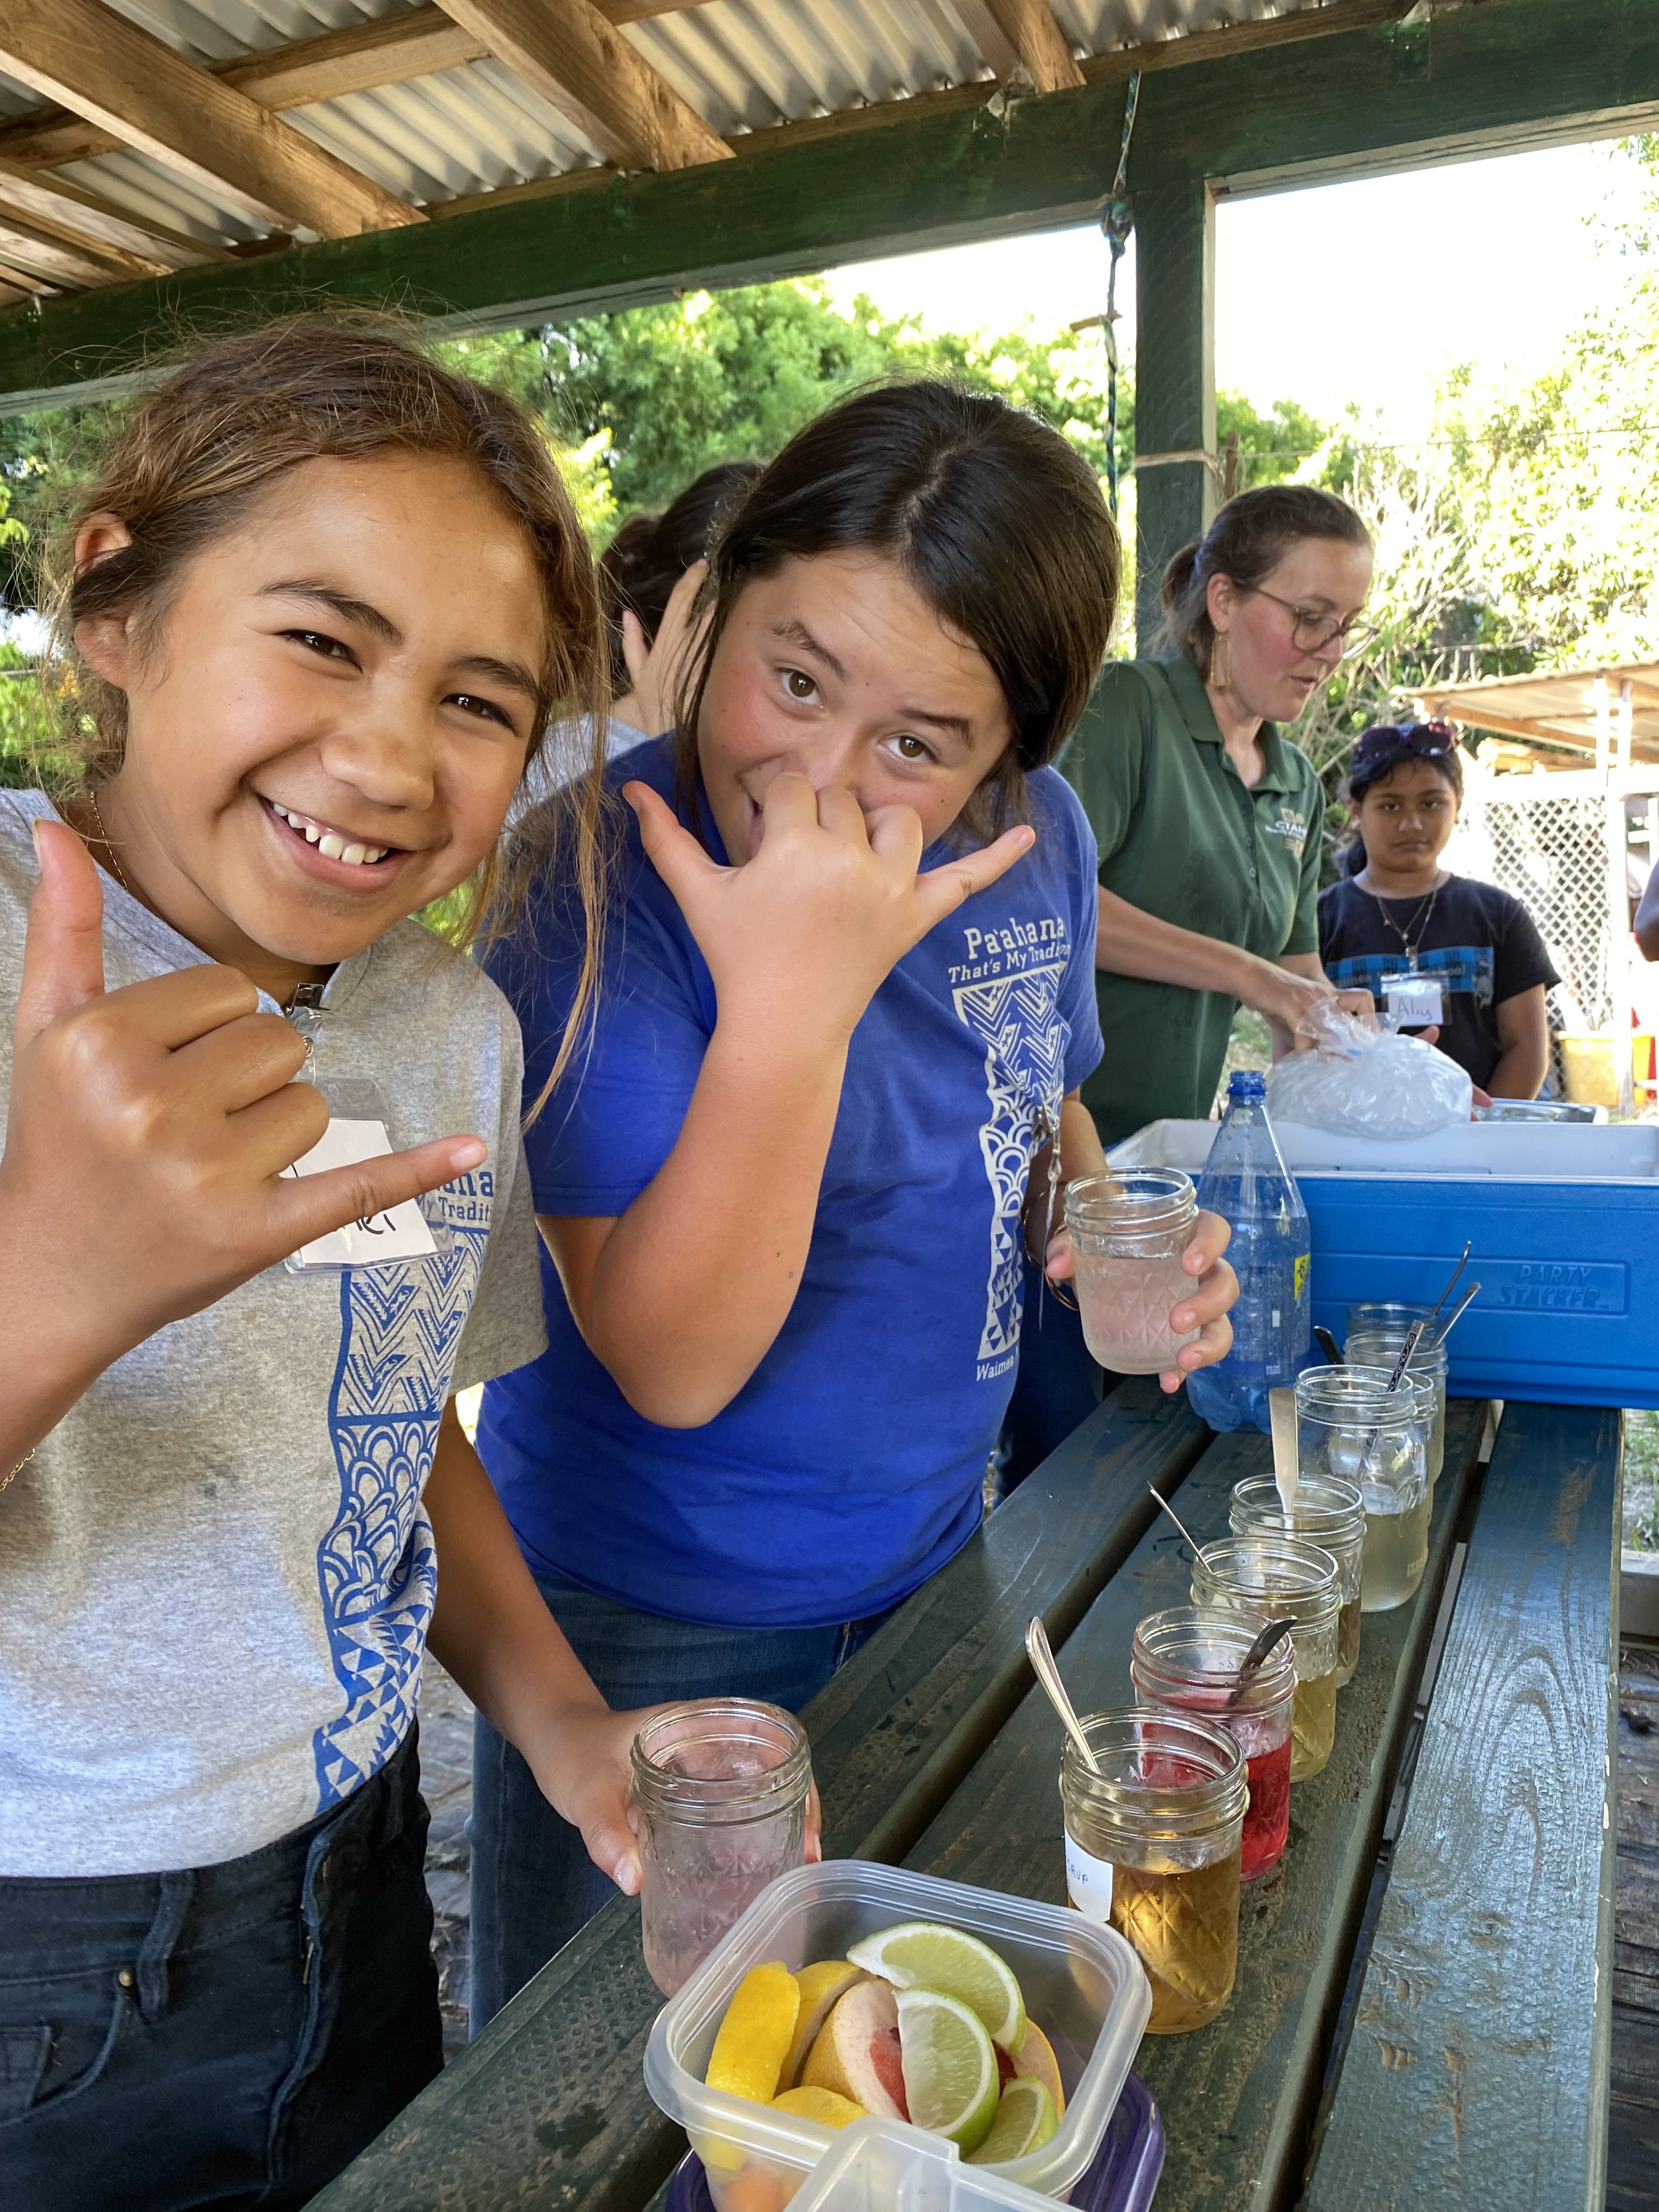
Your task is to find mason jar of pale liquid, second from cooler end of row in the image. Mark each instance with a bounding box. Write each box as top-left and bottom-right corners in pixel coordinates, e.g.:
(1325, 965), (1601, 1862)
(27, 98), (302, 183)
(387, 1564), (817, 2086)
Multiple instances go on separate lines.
(1296, 1367), (1433, 1613)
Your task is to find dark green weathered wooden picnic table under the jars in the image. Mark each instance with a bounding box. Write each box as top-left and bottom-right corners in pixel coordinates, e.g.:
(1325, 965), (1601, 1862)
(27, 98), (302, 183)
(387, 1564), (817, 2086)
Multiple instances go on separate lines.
(314, 1382), (1621, 2212)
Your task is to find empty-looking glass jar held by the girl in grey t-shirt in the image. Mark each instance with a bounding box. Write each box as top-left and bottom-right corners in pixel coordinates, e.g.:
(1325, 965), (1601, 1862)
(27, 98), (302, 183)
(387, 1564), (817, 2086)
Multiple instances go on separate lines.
(630, 1696), (812, 1998)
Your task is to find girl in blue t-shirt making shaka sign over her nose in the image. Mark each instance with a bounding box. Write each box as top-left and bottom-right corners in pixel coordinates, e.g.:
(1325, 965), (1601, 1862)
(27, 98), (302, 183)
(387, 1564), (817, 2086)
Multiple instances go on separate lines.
(473, 383), (1236, 2026)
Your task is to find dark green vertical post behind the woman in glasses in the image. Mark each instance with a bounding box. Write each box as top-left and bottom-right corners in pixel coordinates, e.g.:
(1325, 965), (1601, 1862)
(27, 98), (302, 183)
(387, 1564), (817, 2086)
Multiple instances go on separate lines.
(1135, 177), (1214, 650)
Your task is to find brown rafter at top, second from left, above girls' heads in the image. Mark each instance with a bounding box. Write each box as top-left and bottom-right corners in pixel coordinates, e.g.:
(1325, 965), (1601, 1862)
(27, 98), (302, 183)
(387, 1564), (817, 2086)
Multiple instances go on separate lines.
(431, 0), (732, 171)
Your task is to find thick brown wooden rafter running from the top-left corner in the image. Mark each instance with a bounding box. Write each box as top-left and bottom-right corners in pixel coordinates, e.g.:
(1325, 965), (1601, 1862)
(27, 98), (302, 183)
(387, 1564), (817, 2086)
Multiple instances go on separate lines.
(0, 0), (423, 239)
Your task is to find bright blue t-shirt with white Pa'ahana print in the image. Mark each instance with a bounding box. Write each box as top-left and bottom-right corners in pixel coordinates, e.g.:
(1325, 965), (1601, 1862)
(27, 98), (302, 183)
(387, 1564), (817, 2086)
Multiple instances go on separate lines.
(478, 739), (1100, 1628)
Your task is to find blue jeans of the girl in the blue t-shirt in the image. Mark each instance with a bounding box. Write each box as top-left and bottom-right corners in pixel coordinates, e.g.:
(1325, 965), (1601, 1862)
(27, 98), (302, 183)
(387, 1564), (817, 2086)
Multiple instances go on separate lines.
(471, 1573), (887, 2035)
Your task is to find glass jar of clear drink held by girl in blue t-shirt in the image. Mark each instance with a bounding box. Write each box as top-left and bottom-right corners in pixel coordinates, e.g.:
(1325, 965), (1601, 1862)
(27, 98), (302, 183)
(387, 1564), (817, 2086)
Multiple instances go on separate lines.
(1066, 1168), (1199, 1376)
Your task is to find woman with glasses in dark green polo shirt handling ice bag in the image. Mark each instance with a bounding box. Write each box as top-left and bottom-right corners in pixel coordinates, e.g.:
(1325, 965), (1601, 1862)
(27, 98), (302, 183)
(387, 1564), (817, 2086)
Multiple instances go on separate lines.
(997, 484), (1372, 1489)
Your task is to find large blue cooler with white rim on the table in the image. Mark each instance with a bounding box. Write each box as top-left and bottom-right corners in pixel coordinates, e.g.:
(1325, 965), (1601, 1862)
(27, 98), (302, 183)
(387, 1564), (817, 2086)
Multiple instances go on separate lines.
(1108, 1122), (1659, 1407)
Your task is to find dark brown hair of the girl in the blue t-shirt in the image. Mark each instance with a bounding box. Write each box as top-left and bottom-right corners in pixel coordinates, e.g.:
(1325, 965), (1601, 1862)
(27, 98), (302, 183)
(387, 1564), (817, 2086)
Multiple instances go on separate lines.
(679, 378), (1119, 838)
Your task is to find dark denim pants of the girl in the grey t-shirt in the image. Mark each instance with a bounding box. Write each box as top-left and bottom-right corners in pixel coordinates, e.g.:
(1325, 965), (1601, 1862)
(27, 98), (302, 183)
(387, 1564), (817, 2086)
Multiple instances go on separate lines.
(0, 1732), (443, 2212)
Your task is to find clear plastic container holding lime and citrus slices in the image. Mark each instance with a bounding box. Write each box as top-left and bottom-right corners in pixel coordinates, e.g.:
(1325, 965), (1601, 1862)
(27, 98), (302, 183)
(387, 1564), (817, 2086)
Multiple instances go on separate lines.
(646, 1858), (1153, 2212)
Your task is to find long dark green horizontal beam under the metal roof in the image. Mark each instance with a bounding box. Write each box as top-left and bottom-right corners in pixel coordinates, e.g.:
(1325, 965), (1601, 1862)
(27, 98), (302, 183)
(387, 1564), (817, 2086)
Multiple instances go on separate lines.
(0, 0), (1659, 409)
